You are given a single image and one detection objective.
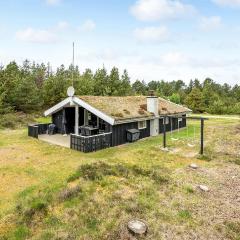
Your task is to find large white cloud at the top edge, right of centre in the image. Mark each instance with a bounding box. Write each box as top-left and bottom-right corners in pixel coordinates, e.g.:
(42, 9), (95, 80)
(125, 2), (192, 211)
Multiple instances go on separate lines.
(130, 0), (195, 21)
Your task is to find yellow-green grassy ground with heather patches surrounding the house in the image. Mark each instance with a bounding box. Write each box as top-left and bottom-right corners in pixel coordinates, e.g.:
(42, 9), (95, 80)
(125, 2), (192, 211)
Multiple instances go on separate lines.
(0, 116), (240, 240)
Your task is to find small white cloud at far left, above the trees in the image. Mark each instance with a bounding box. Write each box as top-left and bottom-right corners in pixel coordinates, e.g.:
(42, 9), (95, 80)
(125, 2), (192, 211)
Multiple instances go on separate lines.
(16, 28), (57, 43)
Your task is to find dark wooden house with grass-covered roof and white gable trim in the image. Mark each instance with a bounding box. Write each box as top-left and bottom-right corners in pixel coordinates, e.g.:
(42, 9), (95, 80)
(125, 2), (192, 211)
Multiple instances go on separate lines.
(30, 96), (191, 152)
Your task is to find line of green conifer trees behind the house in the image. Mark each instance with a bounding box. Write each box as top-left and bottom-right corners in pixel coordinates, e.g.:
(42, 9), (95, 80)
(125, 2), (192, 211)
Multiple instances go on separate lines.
(0, 60), (240, 114)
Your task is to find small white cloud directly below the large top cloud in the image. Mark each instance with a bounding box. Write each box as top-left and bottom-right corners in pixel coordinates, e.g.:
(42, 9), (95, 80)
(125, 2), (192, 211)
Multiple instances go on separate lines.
(134, 26), (169, 43)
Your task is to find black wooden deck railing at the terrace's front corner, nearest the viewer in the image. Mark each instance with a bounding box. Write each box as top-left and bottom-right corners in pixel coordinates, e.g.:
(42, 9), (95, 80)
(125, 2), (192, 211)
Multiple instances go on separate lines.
(70, 132), (112, 153)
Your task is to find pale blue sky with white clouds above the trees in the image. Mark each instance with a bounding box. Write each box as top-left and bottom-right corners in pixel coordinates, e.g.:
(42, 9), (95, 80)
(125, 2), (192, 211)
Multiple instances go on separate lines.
(0, 0), (240, 85)
